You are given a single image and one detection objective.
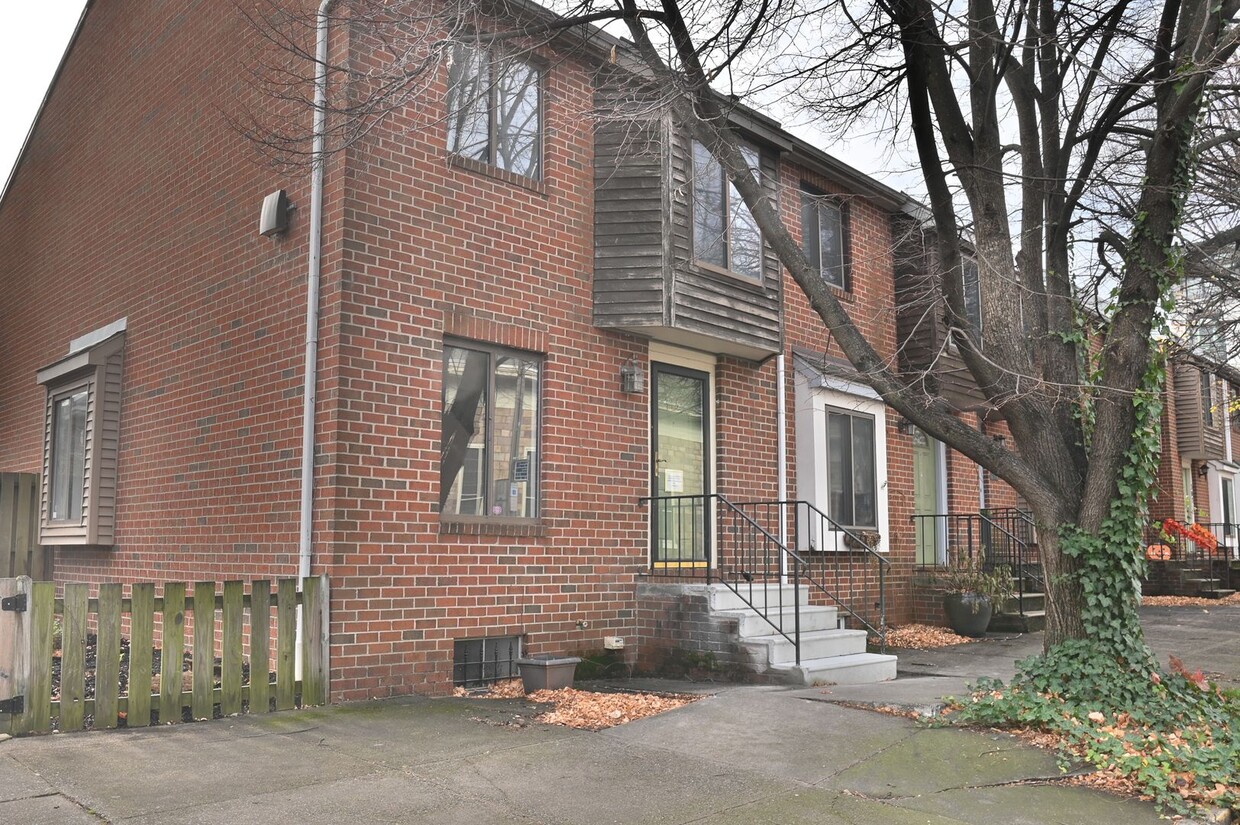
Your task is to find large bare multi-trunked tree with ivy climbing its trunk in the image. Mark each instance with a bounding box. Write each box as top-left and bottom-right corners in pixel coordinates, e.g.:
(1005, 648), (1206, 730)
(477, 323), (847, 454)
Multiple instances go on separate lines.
(246, 0), (1240, 662)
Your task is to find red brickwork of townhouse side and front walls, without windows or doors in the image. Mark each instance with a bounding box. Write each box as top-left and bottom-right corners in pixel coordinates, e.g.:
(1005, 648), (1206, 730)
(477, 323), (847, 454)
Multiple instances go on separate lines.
(0, 4), (1041, 700)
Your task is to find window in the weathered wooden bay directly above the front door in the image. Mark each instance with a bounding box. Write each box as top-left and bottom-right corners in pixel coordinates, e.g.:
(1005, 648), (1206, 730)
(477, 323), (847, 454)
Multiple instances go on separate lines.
(693, 141), (763, 280)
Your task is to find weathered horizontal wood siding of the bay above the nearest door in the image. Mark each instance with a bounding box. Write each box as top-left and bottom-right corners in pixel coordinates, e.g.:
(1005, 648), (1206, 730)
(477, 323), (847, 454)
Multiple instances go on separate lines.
(594, 92), (781, 359)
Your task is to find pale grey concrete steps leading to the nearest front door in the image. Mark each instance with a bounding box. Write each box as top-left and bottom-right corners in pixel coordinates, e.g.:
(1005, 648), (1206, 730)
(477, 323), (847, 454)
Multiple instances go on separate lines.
(709, 583), (895, 685)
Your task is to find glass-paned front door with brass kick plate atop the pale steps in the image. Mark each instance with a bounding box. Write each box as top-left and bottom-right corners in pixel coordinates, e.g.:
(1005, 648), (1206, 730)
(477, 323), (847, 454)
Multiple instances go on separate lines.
(650, 362), (713, 567)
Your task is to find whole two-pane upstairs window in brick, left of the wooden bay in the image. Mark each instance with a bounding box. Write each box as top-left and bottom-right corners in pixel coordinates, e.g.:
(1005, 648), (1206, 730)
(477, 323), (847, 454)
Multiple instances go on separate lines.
(448, 45), (542, 179)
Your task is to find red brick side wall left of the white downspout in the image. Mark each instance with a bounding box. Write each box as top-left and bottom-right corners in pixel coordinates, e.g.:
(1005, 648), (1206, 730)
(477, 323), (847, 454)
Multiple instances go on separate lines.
(0, 4), (322, 582)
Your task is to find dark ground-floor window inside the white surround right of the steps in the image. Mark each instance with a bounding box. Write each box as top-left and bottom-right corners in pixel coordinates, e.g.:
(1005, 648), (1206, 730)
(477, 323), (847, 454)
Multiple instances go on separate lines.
(827, 409), (878, 527)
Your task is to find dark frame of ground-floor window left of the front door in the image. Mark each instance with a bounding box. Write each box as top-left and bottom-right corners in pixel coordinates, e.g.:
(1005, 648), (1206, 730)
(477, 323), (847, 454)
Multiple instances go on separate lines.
(439, 337), (547, 528)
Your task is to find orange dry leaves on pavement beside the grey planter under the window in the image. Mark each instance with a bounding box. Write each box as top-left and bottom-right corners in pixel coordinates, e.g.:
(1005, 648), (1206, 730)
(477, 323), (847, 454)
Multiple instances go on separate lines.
(453, 679), (702, 731)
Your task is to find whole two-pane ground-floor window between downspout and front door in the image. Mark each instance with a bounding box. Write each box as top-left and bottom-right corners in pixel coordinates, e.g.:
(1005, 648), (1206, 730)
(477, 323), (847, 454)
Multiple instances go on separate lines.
(439, 344), (542, 519)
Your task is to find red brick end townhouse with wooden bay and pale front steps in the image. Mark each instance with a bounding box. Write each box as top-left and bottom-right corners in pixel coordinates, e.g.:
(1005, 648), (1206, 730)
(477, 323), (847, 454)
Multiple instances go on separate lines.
(0, 1), (1016, 700)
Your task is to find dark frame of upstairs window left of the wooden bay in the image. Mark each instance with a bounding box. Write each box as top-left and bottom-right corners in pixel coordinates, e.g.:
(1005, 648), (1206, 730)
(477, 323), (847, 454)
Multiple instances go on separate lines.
(445, 43), (547, 181)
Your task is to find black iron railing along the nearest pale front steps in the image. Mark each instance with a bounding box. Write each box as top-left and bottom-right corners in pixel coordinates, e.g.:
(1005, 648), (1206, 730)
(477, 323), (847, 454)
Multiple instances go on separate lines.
(642, 494), (889, 664)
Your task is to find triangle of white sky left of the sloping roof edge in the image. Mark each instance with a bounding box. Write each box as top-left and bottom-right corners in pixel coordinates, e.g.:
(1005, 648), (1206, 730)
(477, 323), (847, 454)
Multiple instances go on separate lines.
(0, 0), (86, 185)
